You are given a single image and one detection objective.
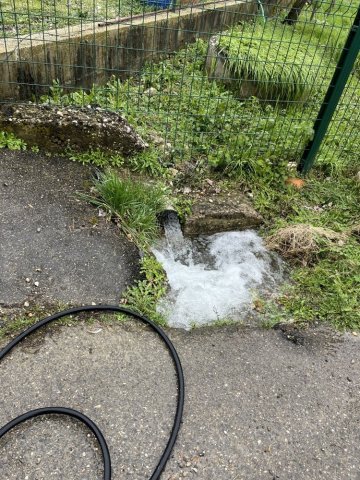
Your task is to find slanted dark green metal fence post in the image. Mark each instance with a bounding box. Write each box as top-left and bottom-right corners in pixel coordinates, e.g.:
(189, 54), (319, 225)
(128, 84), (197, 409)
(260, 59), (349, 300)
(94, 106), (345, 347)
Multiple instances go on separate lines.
(298, 7), (360, 175)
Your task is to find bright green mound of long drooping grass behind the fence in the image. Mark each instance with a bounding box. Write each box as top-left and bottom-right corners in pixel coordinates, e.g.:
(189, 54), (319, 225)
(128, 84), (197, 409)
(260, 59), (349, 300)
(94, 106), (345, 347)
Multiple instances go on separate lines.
(219, 21), (323, 101)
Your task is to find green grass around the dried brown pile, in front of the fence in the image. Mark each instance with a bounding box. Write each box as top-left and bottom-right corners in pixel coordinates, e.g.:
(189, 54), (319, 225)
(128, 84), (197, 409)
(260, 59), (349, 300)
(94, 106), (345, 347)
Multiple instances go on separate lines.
(254, 171), (360, 330)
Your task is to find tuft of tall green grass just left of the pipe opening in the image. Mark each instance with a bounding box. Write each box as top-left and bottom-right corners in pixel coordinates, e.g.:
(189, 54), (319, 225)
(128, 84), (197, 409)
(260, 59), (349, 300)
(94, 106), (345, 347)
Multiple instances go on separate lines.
(86, 172), (165, 249)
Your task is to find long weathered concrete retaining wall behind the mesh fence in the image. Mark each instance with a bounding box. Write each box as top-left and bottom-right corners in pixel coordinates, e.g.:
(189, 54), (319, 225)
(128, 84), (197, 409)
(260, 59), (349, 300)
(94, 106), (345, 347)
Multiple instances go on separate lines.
(0, 0), (258, 101)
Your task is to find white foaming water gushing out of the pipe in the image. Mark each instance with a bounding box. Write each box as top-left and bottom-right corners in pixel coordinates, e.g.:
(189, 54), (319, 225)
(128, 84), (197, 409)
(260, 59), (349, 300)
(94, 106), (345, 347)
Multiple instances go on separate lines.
(153, 213), (284, 329)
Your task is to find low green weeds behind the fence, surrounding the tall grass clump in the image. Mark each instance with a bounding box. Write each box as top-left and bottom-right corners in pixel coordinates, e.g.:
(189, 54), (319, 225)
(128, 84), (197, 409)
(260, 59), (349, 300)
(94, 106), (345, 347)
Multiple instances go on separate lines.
(44, 10), (360, 177)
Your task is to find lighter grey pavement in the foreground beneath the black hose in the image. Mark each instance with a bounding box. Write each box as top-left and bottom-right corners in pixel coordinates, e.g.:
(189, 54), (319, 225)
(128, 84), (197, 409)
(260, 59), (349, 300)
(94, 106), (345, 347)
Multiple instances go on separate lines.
(0, 321), (360, 480)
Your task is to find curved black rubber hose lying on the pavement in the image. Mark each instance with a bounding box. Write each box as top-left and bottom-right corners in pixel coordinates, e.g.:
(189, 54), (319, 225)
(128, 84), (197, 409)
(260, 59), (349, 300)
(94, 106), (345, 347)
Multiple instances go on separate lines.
(0, 305), (185, 480)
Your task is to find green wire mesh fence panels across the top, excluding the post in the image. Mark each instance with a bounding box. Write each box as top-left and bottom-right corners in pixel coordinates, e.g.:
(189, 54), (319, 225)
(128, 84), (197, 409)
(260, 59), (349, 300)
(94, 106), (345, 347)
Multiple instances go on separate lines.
(0, 0), (360, 174)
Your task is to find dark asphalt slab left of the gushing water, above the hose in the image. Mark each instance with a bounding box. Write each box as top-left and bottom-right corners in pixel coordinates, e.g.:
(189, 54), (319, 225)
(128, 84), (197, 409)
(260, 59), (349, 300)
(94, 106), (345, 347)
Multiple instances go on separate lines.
(0, 150), (138, 306)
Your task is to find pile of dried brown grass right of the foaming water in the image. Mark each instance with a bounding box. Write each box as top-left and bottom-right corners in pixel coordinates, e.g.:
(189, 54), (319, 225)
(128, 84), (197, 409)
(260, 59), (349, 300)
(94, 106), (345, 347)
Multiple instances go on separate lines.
(266, 224), (346, 265)
